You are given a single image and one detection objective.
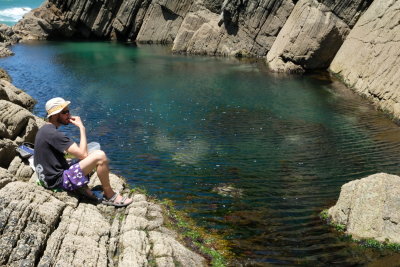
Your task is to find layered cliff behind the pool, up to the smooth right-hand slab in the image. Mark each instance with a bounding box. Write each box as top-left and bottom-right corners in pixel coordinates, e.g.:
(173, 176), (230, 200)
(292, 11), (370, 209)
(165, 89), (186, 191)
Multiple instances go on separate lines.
(10, 0), (372, 60)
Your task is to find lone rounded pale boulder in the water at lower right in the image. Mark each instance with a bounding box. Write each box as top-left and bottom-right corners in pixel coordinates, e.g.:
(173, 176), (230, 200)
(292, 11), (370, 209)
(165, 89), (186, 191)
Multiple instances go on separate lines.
(328, 173), (400, 243)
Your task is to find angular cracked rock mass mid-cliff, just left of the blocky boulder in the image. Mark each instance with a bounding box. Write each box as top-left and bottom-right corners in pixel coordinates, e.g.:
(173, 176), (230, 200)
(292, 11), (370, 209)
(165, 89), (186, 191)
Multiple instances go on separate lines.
(173, 0), (294, 57)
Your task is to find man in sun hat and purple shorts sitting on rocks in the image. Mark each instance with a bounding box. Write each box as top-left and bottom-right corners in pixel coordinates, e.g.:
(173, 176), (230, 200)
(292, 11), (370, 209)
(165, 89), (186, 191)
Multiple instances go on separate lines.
(34, 97), (132, 207)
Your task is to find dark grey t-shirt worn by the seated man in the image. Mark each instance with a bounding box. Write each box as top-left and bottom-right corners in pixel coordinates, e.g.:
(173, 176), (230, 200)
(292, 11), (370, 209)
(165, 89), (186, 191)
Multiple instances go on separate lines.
(34, 124), (74, 188)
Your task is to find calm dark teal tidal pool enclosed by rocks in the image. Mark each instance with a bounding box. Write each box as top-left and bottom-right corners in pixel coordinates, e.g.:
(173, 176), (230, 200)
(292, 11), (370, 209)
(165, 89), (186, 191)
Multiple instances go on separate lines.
(0, 42), (400, 266)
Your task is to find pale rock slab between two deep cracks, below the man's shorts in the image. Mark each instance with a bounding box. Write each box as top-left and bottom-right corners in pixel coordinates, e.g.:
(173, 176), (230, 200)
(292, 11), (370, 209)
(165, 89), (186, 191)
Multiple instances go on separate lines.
(39, 203), (110, 267)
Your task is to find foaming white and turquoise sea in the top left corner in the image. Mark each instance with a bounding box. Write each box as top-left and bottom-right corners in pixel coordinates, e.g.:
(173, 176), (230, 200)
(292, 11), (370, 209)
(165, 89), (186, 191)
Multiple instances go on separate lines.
(0, 0), (43, 26)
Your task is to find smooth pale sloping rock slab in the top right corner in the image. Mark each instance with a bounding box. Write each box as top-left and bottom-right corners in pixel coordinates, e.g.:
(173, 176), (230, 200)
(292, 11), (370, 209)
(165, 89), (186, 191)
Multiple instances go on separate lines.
(329, 0), (400, 118)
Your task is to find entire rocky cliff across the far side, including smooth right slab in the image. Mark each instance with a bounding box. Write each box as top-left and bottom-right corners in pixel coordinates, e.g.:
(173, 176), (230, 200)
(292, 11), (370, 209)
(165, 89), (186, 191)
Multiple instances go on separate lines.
(10, 0), (400, 118)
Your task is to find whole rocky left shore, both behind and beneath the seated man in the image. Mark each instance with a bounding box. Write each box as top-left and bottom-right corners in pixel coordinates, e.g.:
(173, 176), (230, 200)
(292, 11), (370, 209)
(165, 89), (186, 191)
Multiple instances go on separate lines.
(0, 79), (216, 267)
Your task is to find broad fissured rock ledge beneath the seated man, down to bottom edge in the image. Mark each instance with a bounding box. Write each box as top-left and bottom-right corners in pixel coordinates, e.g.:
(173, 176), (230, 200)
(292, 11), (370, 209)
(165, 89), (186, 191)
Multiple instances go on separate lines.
(0, 176), (206, 267)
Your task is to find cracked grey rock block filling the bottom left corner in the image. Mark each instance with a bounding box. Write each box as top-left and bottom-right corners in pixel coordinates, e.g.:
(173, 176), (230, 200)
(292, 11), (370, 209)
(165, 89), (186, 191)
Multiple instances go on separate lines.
(0, 182), (65, 266)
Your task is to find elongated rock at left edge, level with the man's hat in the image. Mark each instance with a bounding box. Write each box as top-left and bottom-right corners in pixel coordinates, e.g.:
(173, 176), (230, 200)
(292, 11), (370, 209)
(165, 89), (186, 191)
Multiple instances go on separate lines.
(0, 79), (36, 110)
